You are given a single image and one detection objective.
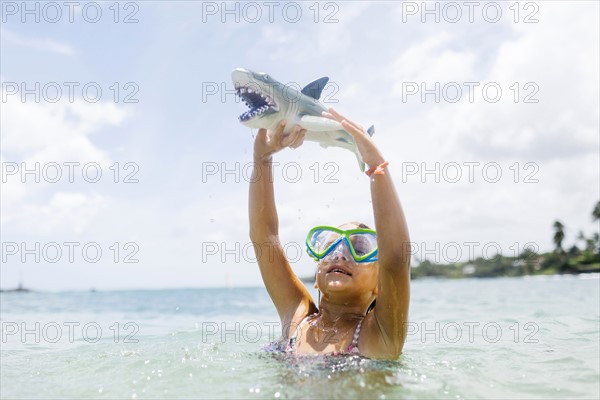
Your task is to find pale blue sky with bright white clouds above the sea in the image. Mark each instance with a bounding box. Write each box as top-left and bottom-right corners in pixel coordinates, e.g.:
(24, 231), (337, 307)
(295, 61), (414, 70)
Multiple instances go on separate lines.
(0, 1), (600, 291)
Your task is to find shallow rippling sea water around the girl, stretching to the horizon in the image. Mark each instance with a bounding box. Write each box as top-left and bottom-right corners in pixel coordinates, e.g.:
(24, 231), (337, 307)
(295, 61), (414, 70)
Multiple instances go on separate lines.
(0, 274), (600, 399)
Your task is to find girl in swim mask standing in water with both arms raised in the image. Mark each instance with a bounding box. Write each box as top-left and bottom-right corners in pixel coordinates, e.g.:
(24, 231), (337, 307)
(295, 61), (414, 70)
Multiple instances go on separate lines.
(249, 108), (410, 359)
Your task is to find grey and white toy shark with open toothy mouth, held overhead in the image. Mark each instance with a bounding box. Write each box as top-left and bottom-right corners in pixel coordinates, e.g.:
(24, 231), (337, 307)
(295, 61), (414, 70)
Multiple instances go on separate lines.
(231, 68), (375, 171)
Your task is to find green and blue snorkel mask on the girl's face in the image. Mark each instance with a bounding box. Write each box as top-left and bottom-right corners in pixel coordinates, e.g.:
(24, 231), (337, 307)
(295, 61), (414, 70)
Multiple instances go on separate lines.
(306, 226), (377, 263)
